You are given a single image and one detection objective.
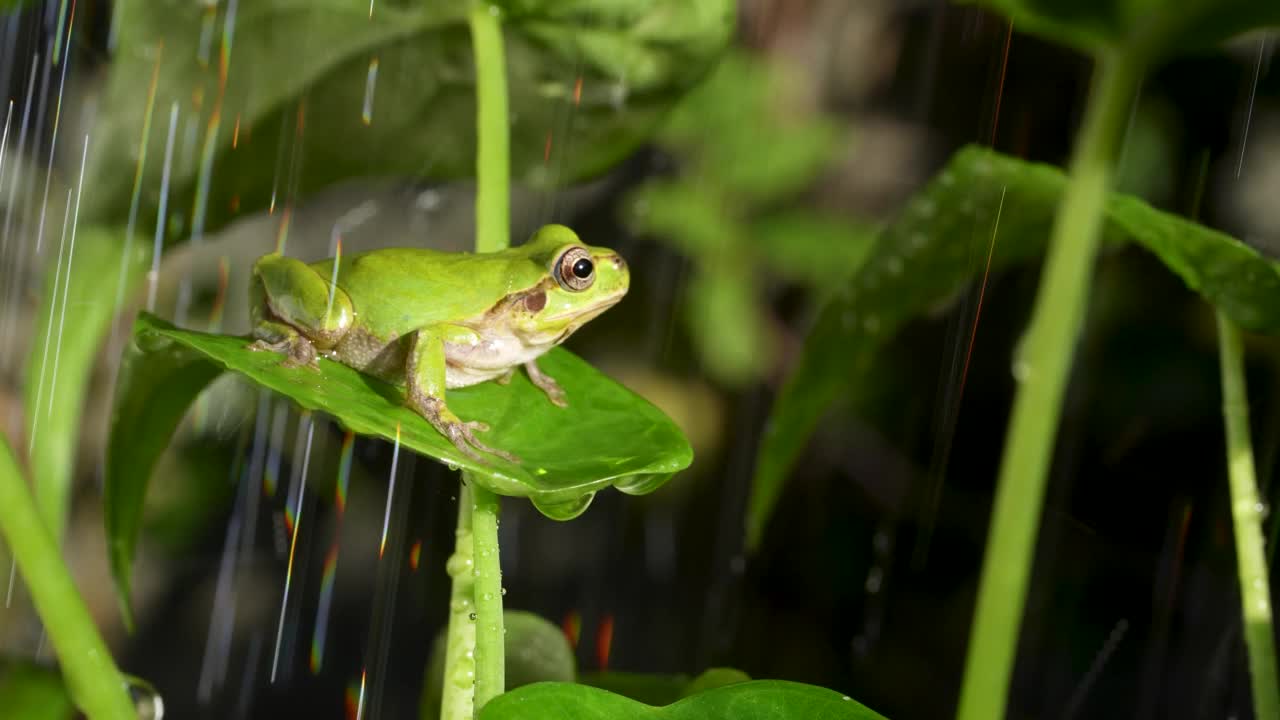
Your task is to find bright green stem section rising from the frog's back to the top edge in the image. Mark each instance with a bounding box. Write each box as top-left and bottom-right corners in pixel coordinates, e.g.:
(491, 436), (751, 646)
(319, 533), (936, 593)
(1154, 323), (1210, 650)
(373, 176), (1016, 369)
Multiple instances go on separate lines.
(470, 3), (511, 252)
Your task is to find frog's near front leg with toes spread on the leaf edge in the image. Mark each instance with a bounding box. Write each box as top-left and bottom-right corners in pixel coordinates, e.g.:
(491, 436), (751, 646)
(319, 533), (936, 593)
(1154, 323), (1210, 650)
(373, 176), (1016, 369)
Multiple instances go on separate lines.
(404, 324), (520, 465)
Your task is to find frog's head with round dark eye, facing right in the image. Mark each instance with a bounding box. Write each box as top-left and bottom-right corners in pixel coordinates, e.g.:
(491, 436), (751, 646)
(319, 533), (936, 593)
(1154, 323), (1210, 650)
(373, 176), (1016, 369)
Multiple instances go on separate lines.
(504, 225), (631, 345)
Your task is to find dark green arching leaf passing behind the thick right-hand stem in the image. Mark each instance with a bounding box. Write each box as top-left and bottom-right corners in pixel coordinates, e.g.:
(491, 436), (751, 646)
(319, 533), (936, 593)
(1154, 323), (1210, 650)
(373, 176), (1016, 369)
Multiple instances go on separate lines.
(746, 146), (1280, 547)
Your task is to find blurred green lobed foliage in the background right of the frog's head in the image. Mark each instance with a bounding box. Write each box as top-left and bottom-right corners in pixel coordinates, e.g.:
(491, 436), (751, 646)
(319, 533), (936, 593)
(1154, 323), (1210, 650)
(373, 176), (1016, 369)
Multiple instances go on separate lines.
(626, 51), (872, 384)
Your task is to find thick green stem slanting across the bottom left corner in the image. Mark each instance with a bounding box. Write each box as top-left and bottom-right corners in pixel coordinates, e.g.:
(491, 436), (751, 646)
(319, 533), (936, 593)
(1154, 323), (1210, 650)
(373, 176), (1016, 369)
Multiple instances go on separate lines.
(0, 441), (134, 720)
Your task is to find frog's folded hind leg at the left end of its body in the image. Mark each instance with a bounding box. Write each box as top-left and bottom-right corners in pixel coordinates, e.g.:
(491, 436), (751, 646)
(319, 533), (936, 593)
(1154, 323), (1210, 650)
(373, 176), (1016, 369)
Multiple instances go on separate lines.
(248, 254), (355, 368)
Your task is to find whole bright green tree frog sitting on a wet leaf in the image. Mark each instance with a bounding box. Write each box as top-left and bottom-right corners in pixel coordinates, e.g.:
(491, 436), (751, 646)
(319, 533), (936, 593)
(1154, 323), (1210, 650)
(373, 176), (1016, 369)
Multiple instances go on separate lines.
(250, 224), (630, 462)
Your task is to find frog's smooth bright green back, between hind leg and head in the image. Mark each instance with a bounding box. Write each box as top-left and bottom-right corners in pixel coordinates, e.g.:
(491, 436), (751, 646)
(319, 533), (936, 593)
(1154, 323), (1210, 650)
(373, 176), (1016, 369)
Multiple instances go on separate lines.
(311, 247), (547, 338)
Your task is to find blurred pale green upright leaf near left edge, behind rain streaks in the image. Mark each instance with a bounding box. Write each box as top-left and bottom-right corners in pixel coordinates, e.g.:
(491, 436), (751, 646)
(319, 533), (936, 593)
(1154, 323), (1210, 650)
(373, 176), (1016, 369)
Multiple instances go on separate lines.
(24, 227), (146, 538)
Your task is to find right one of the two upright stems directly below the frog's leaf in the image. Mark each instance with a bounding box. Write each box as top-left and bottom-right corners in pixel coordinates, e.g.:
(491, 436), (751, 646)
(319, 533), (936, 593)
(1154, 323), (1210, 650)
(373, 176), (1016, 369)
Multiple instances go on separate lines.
(471, 486), (506, 712)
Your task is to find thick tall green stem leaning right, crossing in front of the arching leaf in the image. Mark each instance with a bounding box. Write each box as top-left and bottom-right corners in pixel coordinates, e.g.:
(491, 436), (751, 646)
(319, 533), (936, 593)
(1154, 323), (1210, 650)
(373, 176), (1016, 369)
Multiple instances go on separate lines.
(957, 55), (1142, 720)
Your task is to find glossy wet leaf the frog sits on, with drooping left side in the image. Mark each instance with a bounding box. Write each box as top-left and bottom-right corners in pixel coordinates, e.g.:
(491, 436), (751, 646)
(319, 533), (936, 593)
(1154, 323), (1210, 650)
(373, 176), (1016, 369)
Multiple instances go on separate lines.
(105, 313), (692, 622)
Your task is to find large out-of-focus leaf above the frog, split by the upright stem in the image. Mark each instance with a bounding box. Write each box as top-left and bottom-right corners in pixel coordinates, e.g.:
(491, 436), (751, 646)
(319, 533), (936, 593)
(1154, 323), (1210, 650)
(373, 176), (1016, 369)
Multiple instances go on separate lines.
(86, 0), (735, 240)
